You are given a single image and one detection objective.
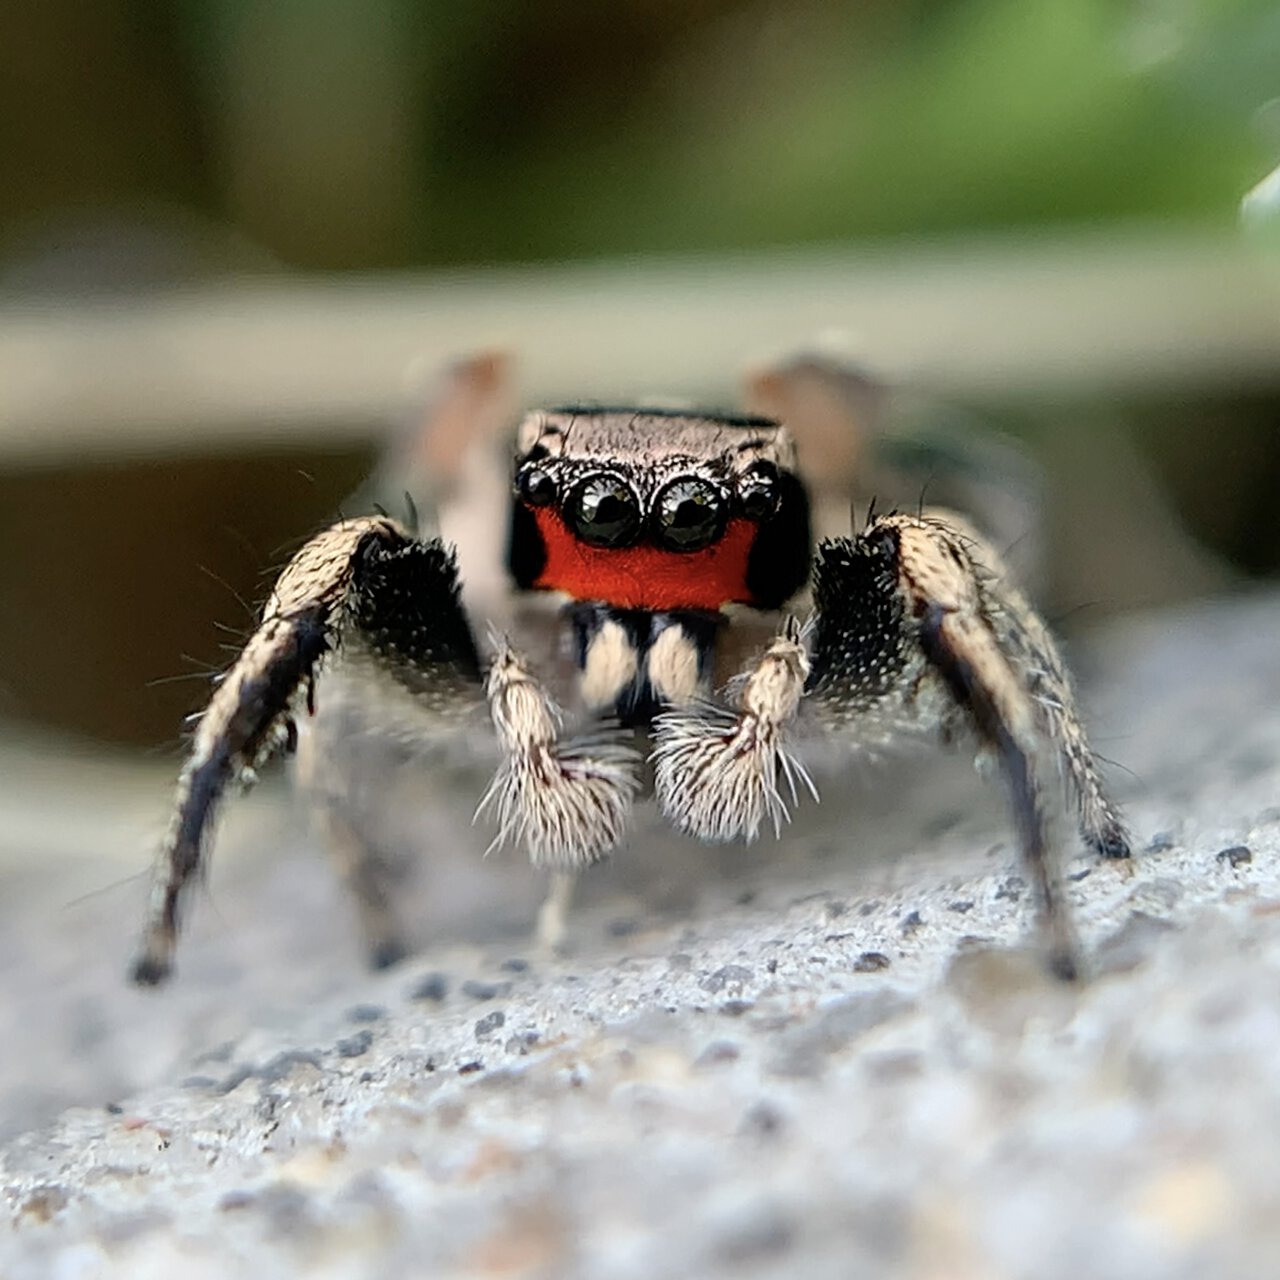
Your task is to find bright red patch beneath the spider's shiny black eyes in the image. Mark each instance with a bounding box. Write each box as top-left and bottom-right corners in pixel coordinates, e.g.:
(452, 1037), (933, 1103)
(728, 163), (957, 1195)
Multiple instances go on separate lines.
(534, 507), (756, 612)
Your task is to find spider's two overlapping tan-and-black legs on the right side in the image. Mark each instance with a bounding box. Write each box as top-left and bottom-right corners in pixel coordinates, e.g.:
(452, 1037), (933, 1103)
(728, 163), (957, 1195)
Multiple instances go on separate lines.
(806, 512), (1129, 978)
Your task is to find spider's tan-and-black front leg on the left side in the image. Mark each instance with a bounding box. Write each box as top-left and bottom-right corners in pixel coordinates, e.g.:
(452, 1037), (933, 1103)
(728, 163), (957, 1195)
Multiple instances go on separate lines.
(132, 517), (480, 986)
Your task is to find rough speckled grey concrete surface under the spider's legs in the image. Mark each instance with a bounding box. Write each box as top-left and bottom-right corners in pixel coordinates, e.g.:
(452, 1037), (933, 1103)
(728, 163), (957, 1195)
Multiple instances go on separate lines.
(0, 596), (1280, 1280)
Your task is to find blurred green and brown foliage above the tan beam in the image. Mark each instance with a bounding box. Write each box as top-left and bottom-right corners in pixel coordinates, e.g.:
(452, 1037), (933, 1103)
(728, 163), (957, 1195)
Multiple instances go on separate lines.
(0, 0), (1280, 275)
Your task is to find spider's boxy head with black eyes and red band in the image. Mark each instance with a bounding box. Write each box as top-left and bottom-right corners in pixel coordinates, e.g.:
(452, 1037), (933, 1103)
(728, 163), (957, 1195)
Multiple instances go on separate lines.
(508, 408), (810, 613)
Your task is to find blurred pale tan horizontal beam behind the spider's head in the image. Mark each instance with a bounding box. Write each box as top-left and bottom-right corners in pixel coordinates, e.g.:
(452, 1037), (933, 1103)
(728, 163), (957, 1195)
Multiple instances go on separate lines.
(0, 229), (1280, 466)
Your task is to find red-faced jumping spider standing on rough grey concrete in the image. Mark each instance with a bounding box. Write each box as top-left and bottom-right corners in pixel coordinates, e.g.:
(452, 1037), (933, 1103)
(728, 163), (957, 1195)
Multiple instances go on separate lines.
(133, 394), (1129, 983)
